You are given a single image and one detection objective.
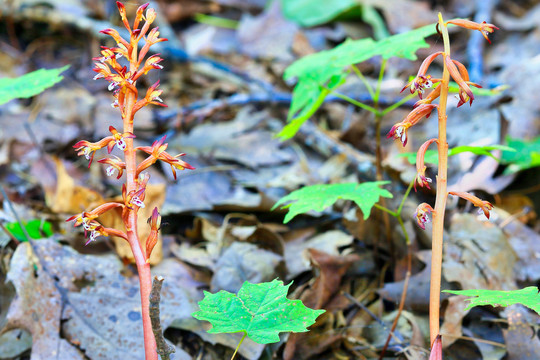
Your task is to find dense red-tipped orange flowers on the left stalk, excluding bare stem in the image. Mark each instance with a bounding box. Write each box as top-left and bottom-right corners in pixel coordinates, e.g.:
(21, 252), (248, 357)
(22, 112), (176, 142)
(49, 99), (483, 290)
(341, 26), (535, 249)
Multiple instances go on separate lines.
(68, 2), (193, 258)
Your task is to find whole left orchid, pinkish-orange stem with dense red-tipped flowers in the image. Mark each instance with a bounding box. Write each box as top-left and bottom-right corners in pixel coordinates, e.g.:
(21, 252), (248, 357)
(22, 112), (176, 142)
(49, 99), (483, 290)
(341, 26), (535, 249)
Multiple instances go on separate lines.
(67, 2), (193, 360)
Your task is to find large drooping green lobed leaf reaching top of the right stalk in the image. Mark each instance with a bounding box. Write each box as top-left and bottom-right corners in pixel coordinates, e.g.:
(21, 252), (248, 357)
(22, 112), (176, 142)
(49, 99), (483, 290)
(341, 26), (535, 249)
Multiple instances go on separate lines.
(278, 25), (436, 140)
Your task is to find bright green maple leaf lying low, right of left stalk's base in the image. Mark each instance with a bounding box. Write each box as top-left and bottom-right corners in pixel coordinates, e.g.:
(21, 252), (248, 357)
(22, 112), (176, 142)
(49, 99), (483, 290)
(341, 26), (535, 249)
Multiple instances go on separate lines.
(191, 279), (325, 344)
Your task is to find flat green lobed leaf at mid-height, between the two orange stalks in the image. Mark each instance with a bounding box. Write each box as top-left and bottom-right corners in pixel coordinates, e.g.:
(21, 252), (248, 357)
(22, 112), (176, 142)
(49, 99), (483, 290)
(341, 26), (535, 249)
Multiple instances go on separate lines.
(272, 181), (393, 223)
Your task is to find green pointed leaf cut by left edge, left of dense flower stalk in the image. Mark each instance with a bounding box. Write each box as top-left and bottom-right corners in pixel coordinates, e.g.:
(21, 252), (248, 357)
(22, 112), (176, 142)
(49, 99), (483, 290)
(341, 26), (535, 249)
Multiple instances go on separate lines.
(0, 65), (69, 105)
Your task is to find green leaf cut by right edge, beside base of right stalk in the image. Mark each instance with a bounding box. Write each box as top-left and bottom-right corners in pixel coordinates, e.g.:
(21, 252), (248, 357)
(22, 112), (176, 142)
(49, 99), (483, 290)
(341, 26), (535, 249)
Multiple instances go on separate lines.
(443, 286), (540, 314)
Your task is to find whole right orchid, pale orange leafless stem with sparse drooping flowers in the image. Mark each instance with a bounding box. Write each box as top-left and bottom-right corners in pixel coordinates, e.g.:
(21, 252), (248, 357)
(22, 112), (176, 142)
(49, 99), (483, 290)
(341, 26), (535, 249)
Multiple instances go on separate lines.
(388, 13), (498, 359)
